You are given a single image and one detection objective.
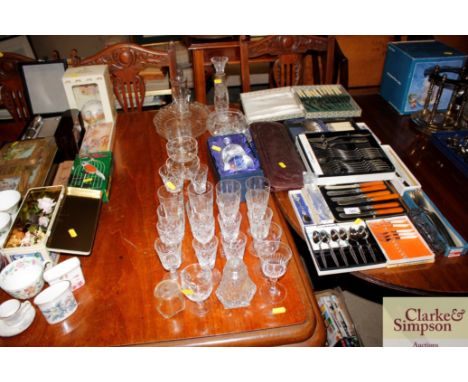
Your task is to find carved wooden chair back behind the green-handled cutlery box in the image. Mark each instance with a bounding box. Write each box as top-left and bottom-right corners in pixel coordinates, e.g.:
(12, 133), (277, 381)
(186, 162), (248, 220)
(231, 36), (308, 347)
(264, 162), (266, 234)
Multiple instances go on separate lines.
(239, 35), (335, 92)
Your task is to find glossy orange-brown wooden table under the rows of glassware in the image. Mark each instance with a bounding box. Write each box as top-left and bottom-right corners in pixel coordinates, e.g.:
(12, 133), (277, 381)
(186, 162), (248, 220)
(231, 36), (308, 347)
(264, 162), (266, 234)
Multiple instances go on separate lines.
(0, 112), (325, 346)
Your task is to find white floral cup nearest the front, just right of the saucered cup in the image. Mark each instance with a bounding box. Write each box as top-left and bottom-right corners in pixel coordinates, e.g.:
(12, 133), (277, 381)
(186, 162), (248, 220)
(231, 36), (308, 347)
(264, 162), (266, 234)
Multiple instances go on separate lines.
(34, 280), (78, 324)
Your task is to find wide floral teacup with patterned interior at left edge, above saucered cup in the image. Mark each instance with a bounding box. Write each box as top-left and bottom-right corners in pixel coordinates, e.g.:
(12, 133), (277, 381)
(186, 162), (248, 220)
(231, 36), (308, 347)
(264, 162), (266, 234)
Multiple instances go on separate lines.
(0, 257), (52, 300)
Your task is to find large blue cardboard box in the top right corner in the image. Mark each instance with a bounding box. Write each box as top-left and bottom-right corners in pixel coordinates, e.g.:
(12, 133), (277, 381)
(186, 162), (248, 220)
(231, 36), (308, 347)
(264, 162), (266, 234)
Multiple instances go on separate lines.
(380, 40), (467, 114)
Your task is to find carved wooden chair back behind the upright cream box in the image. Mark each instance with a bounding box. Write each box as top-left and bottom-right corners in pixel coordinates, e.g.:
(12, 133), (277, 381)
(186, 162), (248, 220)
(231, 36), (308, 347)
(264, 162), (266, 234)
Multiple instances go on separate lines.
(75, 42), (176, 112)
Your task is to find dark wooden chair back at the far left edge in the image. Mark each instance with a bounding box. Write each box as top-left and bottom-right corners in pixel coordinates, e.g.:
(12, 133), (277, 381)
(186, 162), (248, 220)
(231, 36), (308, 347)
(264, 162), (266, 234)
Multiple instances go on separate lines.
(0, 52), (33, 124)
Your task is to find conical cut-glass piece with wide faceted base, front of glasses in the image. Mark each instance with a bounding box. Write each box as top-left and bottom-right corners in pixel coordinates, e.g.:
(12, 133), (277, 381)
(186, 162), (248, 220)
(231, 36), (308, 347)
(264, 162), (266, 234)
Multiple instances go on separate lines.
(216, 257), (257, 309)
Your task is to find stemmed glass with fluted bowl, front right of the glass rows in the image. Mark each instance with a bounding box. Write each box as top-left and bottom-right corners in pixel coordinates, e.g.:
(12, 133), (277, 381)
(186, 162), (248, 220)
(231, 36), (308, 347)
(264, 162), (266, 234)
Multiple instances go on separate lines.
(259, 242), (292, 304)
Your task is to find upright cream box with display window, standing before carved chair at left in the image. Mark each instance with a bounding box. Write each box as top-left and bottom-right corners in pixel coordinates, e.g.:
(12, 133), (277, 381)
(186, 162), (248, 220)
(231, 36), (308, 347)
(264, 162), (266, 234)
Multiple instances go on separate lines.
(62, 65), (117, 128)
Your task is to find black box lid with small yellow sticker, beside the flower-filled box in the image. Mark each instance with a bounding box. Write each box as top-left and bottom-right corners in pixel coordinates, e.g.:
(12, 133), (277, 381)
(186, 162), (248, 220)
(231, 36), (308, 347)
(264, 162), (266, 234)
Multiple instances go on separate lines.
(46, 187), (102, 256)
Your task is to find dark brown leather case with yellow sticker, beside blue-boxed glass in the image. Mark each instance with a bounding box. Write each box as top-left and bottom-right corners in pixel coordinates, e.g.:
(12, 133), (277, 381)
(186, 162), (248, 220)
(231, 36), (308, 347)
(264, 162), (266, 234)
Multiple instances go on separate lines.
(250, 122), (305, 191)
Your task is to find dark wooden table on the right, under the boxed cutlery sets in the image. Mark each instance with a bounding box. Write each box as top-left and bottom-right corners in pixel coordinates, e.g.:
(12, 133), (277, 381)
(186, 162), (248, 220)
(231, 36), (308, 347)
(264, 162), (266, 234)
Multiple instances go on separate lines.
(275, 95), (468, 295)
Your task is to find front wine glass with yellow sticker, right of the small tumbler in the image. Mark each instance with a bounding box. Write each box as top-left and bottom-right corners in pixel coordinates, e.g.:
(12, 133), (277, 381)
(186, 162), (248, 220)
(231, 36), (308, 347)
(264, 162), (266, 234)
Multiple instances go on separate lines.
(180, 264), (213, 317)
